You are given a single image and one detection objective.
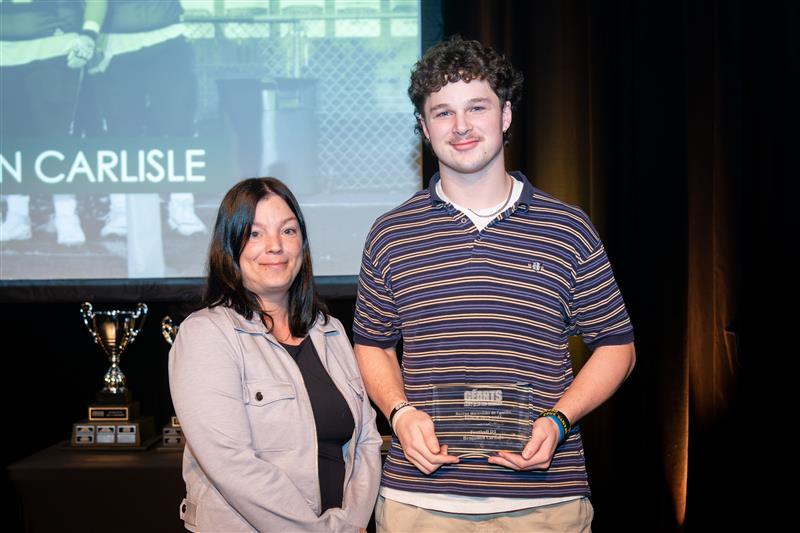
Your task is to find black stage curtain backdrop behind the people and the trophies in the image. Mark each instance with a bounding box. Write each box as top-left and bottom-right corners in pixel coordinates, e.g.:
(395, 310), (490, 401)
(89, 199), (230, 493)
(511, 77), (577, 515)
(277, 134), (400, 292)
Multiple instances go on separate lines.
(0, 0), (800, 532)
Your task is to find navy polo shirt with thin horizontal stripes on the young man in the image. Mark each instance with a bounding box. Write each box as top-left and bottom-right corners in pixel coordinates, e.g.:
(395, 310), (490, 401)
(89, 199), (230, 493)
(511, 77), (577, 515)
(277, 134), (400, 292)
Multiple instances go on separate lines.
(353, 172), (633, 498)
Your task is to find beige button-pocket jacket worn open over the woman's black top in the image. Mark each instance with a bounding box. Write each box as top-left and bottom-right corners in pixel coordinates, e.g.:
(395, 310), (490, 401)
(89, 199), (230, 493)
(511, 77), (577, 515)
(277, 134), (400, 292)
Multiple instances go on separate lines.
(169, 307), (381, 532)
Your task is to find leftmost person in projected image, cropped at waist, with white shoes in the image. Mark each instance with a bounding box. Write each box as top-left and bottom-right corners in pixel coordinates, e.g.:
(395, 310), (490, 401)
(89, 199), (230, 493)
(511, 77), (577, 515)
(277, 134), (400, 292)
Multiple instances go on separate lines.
(0, 0), (105, 246)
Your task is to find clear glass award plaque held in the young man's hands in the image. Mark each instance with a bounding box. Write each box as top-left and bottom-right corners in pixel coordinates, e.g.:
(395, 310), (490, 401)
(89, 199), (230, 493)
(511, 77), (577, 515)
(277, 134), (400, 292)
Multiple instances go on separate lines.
(430, 383), (535, 457)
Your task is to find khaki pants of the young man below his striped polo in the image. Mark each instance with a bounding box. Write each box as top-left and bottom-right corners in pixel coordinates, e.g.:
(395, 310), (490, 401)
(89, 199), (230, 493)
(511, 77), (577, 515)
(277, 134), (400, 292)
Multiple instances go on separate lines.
(375, 496), (594, 533)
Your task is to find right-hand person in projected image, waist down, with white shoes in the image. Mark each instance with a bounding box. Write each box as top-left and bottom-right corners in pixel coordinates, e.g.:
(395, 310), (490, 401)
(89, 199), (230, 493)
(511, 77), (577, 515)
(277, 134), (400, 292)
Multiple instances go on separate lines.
(88, 0), (208, 237)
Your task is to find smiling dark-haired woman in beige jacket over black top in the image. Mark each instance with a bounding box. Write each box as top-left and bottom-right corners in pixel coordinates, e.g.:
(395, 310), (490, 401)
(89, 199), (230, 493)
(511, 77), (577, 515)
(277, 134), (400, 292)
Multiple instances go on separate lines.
(169, 178), (381, 531)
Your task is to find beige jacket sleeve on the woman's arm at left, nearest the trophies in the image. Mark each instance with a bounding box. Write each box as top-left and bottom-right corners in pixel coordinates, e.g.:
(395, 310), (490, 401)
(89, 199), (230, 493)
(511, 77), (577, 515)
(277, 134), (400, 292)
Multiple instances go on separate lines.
(169, 316), (357, 531)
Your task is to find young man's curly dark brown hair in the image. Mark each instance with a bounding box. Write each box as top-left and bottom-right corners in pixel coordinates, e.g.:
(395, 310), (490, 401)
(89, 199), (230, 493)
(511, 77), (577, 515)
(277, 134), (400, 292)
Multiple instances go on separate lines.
(408, 35), (523, 144)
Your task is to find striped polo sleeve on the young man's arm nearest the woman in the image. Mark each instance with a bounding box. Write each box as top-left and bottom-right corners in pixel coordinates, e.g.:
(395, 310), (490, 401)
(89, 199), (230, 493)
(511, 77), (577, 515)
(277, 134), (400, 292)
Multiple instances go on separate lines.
(353, 235), (401, 348)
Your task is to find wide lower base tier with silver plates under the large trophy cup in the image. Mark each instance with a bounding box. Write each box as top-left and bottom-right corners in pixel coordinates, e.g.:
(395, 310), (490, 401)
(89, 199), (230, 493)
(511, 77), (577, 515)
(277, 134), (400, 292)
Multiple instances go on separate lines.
(70, 416), (155, 450)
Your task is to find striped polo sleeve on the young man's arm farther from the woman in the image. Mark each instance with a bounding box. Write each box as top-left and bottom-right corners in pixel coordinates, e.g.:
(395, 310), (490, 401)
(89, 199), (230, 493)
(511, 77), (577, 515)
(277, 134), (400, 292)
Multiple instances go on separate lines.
(569, 240), (633, 350)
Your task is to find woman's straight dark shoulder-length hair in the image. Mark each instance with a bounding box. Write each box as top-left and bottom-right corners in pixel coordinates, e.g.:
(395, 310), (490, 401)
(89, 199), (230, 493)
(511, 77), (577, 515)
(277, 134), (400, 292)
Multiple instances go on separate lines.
(203, 178), (327, 337)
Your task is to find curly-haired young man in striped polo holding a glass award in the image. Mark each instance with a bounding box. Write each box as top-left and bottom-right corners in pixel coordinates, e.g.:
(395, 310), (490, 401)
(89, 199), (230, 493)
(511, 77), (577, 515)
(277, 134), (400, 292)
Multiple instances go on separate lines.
(353, 38), (635, 531)
